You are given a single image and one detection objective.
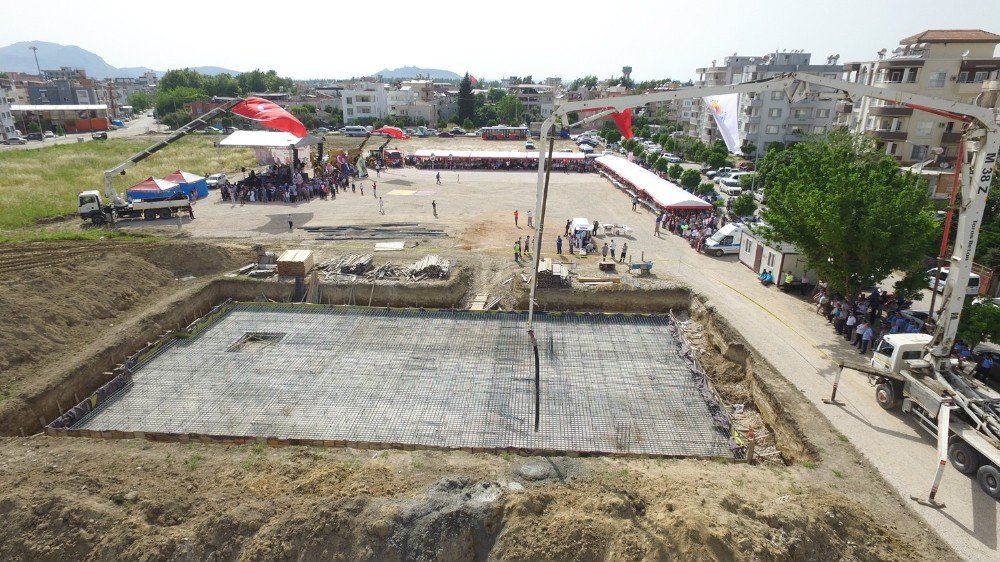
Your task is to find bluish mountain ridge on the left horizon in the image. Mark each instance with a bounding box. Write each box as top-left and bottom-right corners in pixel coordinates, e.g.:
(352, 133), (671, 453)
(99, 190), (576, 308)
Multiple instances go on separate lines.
(0, 41), (239, 78)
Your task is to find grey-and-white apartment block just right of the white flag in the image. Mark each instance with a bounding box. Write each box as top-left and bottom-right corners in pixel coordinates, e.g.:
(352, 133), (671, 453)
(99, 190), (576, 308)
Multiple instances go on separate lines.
(734, 50), (843, 157)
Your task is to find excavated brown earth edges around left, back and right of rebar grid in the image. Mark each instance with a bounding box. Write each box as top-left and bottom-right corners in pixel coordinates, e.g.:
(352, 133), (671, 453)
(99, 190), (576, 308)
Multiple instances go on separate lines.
(9, 276), (817, 464)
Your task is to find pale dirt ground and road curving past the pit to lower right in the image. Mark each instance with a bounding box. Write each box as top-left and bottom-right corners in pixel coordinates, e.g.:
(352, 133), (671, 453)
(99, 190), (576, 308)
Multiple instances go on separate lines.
(136, 161), (1000, 560)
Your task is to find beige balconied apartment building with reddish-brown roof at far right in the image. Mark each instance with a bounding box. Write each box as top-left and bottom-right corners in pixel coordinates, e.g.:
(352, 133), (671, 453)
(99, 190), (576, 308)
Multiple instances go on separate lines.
(836, 29), (1000, 164)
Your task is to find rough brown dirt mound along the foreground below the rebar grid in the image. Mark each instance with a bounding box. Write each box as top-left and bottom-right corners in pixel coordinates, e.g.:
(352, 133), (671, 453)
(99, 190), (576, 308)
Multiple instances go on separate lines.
(0, 438), (950, 561)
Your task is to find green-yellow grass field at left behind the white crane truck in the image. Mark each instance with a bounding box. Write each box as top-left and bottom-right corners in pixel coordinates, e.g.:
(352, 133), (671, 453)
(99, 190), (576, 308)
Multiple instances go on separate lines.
(0, 137), (255, 231)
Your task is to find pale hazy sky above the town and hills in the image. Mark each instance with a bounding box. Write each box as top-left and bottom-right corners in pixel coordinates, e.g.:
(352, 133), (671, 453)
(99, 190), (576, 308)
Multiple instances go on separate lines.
(0, 0), (1000, 81)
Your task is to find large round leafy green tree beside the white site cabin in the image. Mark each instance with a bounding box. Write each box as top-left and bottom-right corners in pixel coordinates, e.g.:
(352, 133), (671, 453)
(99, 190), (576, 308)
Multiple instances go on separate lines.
(758, 131), (934, 295)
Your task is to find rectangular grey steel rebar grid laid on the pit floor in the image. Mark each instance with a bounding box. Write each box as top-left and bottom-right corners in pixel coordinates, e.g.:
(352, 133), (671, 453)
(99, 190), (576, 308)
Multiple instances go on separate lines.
(60, 303), (734, 458)
